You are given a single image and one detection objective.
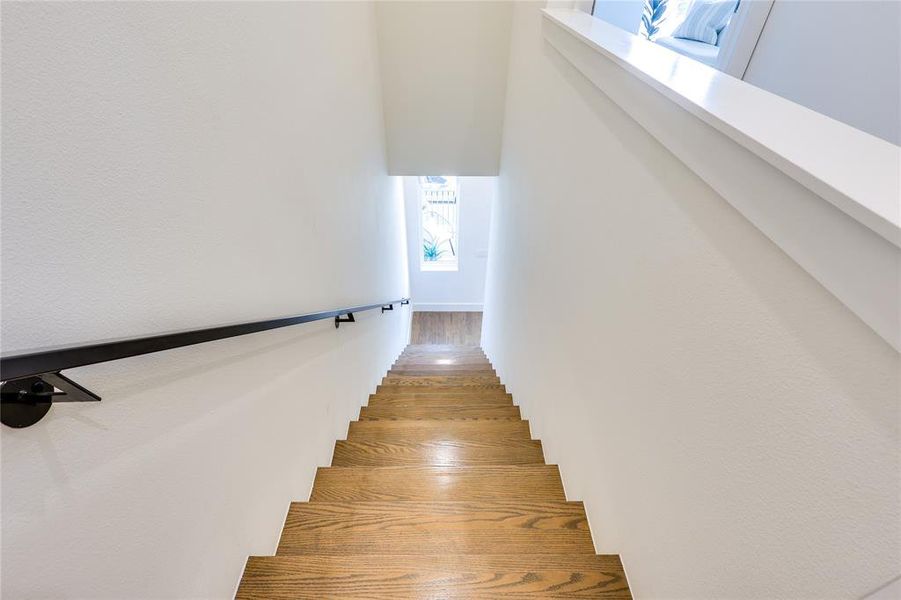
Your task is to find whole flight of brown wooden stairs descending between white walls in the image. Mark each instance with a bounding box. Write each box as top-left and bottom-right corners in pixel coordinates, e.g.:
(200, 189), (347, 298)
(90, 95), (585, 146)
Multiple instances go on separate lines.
(237, 345), (631, 600)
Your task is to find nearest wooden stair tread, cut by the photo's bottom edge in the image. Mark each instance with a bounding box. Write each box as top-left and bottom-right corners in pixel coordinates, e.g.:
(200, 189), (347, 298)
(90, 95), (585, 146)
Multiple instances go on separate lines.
(236, 554), (631, 600)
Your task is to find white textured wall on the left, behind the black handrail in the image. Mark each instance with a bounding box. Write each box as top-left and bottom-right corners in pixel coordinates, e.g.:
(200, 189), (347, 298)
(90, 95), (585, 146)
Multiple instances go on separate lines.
(0, 2), (409, 598)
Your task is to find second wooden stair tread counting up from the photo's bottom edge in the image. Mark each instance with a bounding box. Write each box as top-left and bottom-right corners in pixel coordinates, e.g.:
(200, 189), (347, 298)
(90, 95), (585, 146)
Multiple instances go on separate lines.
(278, 502), (594, 555)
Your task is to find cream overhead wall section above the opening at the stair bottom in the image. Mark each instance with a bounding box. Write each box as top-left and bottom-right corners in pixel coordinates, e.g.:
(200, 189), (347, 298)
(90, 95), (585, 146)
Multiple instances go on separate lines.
(377, 1), (513, 175)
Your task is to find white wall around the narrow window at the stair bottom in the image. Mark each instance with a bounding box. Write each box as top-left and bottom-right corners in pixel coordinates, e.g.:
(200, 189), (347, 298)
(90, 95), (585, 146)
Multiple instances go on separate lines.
(404, 177), (497, 311)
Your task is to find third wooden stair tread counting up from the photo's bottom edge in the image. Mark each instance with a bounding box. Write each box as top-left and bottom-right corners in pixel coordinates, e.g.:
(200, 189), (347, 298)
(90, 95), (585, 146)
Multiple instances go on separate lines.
(310, 465), (566, 502)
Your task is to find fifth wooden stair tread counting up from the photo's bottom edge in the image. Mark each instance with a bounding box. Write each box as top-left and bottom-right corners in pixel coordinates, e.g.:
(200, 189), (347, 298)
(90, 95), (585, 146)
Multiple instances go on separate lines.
(347, 420), (532, 442)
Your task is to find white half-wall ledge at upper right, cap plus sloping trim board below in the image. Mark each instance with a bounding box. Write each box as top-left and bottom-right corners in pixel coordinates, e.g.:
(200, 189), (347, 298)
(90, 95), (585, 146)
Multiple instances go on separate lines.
(544, 9), (901, 350)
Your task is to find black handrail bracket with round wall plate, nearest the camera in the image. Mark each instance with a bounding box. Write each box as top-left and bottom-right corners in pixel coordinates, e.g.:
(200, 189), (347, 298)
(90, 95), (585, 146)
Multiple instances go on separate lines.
(0, 372), (100, 429)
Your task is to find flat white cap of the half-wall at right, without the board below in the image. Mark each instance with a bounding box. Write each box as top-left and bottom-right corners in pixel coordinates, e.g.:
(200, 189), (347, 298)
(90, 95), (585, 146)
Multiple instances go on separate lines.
(543, 9), (901, 248)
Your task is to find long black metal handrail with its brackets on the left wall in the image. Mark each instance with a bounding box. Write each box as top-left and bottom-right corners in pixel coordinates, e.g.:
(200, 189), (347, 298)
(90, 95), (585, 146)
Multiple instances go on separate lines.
(0, 298), (410, 427)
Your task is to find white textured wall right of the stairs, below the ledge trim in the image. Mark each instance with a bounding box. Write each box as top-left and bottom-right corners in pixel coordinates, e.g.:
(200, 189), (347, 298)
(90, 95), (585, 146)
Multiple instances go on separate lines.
(483, 3), (901, 600)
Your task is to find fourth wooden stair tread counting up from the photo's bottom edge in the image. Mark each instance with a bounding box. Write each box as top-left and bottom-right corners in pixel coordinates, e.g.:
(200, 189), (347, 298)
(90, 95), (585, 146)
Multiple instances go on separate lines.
(332, 440), (544, 467)
